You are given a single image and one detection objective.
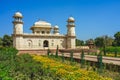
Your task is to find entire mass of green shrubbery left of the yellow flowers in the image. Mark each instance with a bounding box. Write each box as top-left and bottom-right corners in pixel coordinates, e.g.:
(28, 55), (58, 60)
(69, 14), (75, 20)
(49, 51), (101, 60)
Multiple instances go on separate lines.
(0, 47), (59, 80)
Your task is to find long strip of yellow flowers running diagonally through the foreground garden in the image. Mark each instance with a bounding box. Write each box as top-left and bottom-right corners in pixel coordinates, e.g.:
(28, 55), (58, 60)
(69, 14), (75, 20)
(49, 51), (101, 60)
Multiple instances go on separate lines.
(33, 55), (112, 80)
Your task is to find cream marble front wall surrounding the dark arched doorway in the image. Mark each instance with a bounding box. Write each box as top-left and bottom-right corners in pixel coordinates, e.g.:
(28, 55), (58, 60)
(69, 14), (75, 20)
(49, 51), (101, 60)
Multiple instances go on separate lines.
(16, 37), (66, 50)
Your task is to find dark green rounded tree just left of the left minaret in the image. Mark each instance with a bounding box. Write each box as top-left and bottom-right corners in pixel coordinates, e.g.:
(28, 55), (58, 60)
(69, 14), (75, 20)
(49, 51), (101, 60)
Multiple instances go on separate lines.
(2, 35), (13, 47)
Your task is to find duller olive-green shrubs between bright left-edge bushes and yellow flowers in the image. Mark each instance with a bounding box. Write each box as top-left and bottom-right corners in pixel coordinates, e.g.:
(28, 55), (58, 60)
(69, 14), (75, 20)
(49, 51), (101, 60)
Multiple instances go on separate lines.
(10, 54), (43, 80)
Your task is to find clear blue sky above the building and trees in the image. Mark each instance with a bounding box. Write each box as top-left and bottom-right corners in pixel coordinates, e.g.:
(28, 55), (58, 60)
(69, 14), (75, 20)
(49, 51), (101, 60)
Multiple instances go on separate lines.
(0, 0), (120, 40)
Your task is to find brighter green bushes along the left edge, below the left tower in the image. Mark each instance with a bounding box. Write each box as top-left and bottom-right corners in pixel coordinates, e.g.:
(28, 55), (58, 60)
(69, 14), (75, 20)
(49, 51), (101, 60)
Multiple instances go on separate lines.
(0, 47), (18, 80)
